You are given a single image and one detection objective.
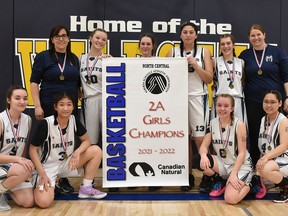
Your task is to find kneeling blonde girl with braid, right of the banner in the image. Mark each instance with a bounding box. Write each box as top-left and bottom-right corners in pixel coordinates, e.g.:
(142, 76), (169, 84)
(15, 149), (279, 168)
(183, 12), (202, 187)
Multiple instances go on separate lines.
(195, 94), (252, 204)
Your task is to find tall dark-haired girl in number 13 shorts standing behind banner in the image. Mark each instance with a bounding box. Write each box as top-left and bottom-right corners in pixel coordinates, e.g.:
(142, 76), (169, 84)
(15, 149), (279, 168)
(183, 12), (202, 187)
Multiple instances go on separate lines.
(166, 22), (213, 191)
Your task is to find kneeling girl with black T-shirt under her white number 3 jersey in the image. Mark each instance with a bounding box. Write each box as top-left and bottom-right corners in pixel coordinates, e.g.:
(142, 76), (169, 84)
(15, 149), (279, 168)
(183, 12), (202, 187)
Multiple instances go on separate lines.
(30, 92), (107, 208)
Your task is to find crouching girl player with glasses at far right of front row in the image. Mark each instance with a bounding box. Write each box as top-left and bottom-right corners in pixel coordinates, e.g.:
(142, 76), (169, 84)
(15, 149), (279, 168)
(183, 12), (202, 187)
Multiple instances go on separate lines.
(256, 90), (288, 203)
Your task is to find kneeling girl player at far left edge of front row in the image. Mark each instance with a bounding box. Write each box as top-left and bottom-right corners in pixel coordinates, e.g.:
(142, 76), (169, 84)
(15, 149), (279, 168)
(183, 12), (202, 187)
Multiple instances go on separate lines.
(0, 86), (34, 212)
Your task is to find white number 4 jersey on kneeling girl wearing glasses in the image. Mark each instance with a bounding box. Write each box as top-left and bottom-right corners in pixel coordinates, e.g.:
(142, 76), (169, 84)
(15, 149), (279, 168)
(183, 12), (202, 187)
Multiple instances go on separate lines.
(258, 113), (288, 158)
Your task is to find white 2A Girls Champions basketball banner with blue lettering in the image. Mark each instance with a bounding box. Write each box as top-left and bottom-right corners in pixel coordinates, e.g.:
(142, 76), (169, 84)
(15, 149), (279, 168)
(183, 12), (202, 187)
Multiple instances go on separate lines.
(102, 58), (188, 187)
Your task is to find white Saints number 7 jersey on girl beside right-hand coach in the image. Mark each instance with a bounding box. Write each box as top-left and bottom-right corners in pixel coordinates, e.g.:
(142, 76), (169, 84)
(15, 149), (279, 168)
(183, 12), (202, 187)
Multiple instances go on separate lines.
(213, 56), (244, 97)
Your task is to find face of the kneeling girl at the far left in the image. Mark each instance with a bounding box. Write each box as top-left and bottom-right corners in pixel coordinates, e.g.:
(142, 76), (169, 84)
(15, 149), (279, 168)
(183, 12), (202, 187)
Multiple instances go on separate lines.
(7, 89), (28, 112)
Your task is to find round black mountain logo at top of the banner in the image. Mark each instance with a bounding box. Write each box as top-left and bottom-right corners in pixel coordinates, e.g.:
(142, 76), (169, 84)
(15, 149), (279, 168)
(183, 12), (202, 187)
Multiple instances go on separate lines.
(143, 70), (170, 94)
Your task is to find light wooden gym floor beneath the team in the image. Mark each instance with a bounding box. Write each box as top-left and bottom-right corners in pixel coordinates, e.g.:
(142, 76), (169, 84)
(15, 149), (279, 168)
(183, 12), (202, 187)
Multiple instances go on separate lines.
(0, 171), (288, 216)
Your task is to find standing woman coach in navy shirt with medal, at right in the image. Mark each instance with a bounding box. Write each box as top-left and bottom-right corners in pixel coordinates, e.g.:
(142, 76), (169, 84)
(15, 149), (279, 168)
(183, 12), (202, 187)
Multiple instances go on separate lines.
(239, 24), (288, 169)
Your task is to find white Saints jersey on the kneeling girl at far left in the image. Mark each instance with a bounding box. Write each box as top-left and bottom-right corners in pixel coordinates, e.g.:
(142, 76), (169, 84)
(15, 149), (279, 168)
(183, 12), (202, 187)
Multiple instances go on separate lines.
(0, 110), (31, 156)
